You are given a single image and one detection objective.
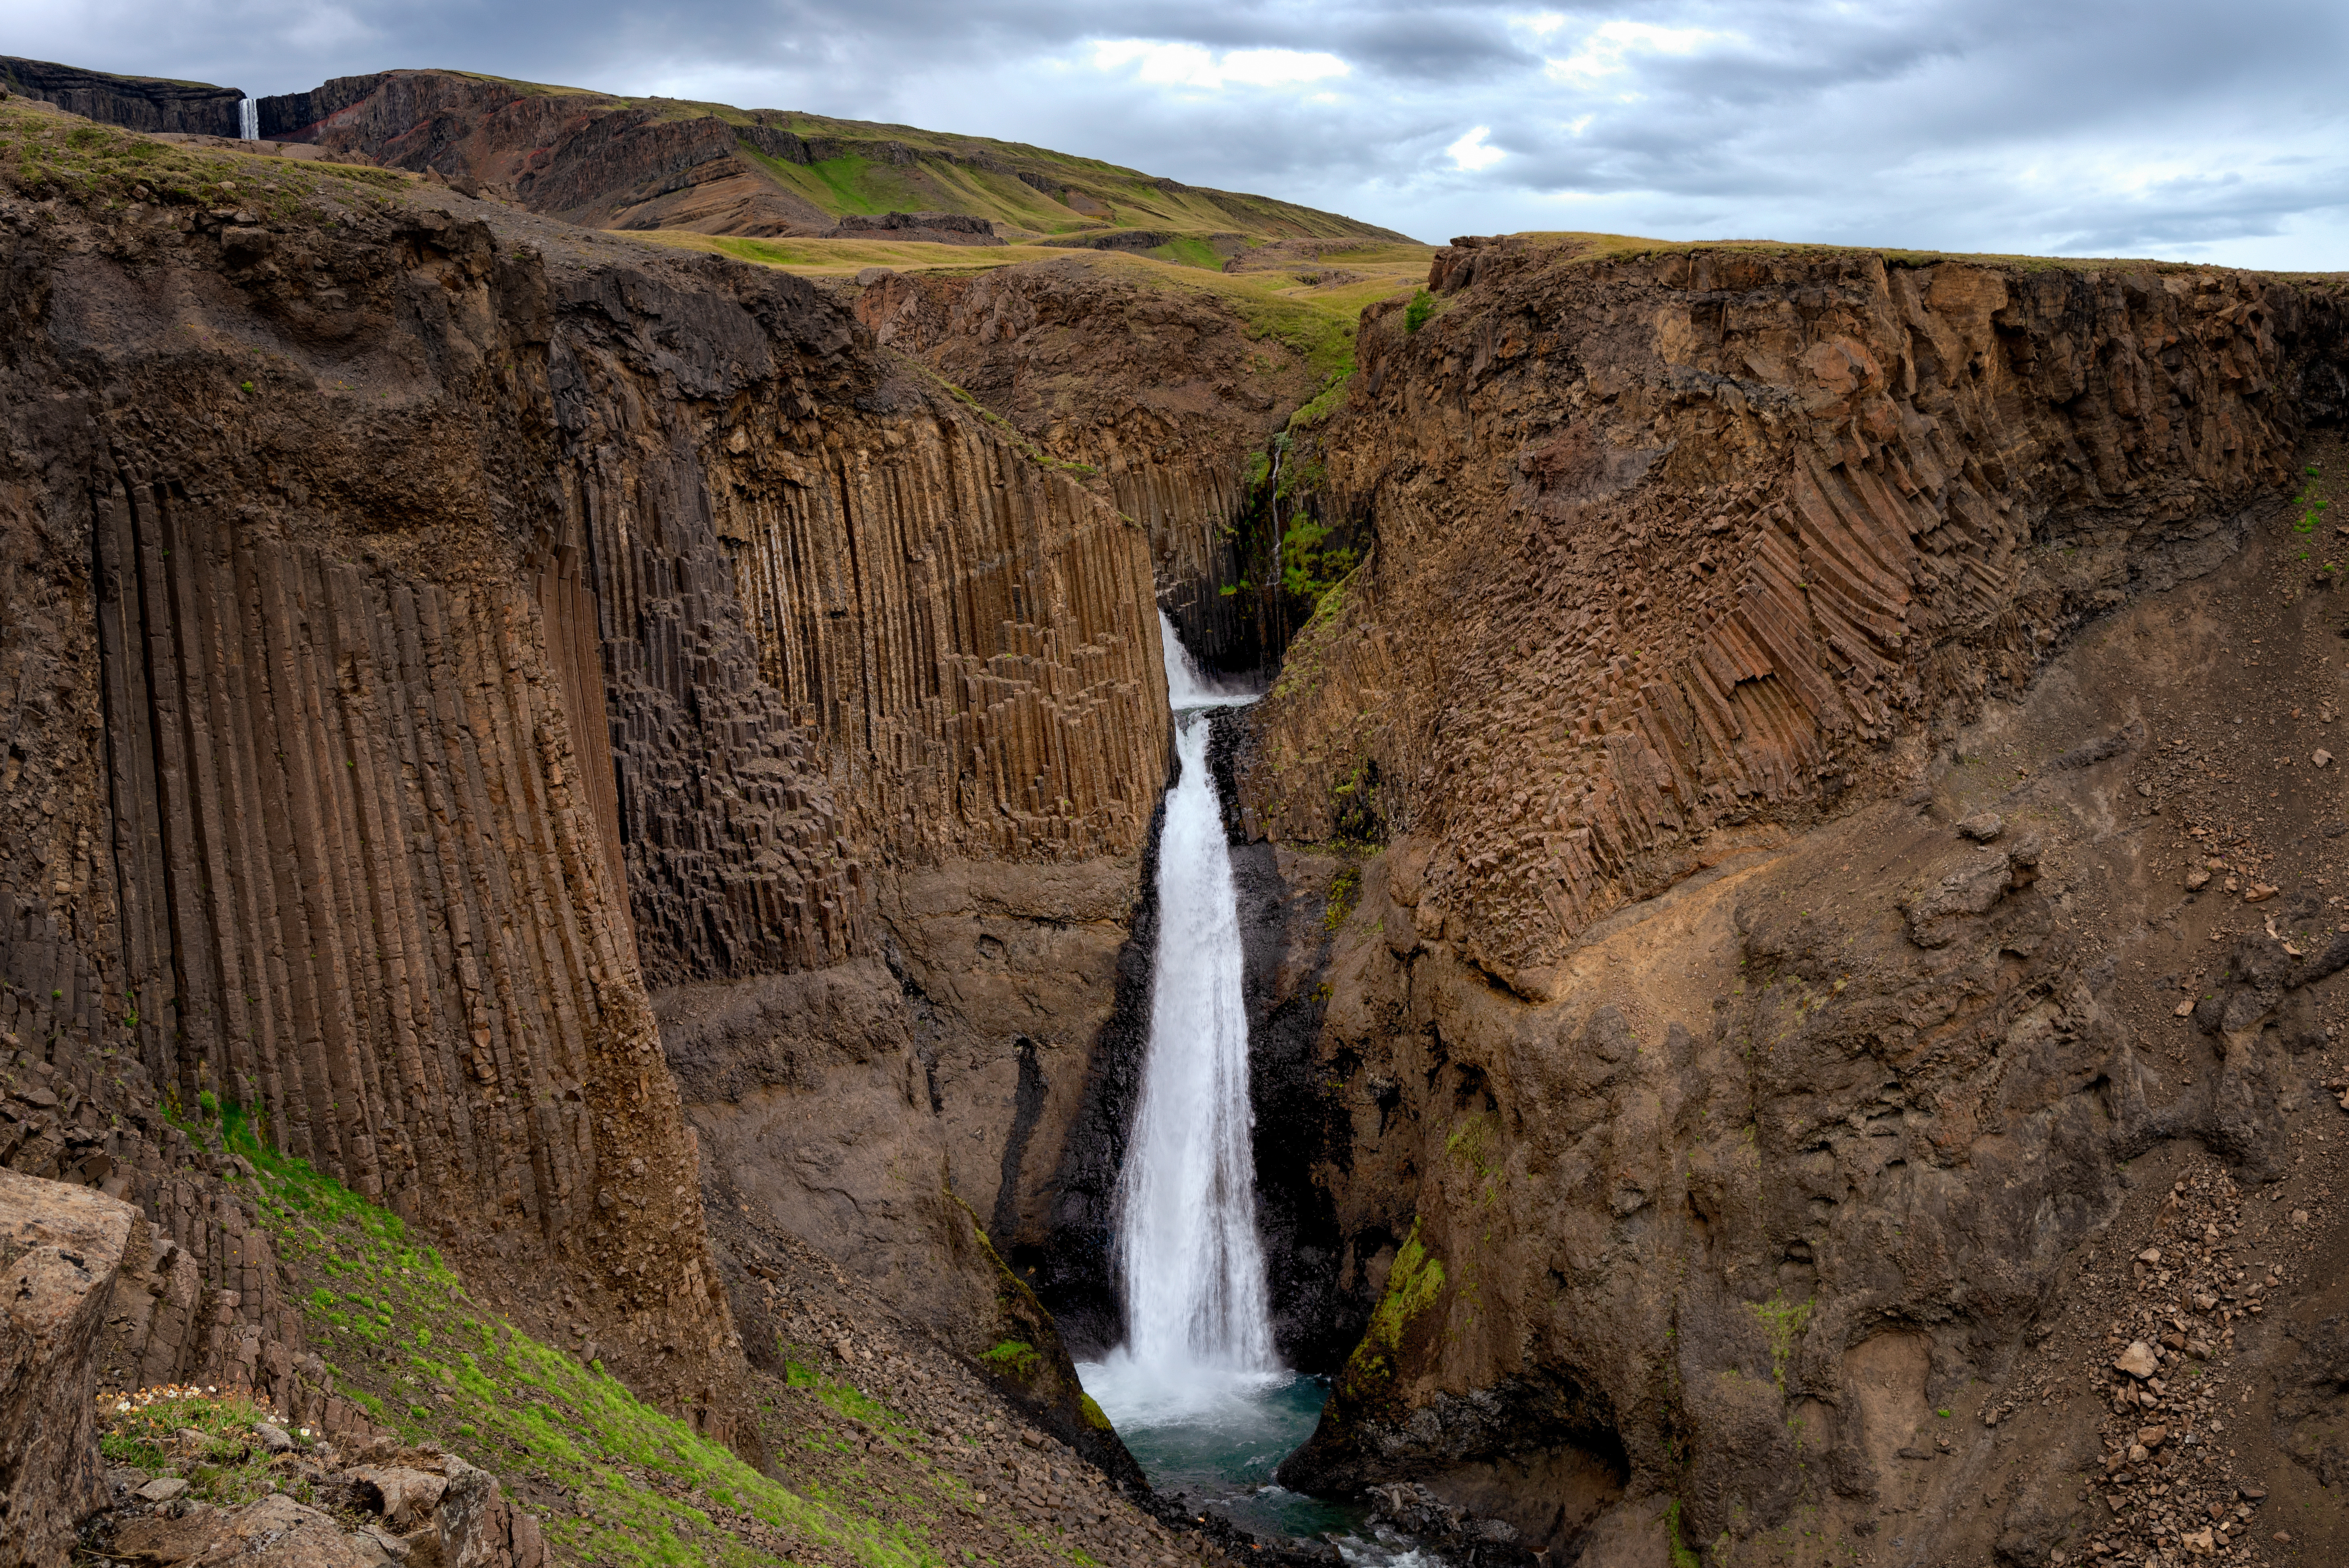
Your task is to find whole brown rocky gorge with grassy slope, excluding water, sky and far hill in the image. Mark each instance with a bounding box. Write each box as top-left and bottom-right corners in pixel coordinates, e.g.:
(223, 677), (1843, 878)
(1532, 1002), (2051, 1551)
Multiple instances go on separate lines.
(14, 73), (2349, 1568)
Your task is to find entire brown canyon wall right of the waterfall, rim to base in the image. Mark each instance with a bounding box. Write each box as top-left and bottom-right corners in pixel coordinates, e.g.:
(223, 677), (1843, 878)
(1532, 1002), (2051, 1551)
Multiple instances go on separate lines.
(1238, 240), (2344, 1563)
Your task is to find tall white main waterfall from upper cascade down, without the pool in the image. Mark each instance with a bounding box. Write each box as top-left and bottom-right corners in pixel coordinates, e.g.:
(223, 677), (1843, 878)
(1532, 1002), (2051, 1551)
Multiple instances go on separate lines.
(1118, 615), (1275, 1378)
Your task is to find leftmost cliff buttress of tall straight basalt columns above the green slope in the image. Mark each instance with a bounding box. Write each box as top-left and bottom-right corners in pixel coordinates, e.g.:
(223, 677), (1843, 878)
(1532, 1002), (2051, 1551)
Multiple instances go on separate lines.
(0, 171), (747, 1436)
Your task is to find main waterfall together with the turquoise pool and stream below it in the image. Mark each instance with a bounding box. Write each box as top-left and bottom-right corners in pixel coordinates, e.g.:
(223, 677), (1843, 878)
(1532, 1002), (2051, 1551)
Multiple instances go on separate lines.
(1076, 615), (1431, 1568)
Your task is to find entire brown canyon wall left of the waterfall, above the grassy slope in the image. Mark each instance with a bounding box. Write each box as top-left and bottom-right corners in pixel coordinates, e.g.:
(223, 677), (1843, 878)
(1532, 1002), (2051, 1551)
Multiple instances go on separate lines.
(0, 113), (1165, 1453)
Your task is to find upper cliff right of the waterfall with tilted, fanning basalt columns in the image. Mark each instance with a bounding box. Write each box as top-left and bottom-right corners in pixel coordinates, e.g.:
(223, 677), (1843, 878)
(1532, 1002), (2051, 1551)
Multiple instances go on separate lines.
(1245, 242), (2335, 998)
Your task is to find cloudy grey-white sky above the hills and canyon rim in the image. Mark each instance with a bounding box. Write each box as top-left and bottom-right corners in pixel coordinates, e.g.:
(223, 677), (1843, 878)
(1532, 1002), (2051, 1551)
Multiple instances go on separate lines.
(0, 0), (2349, 270)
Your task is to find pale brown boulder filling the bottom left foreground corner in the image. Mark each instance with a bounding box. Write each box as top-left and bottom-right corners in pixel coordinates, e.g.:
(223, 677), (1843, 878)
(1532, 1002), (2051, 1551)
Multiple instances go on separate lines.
(0, 1169), (136, 1568)
